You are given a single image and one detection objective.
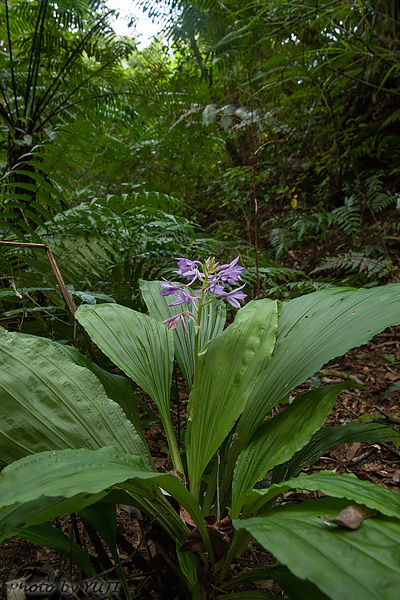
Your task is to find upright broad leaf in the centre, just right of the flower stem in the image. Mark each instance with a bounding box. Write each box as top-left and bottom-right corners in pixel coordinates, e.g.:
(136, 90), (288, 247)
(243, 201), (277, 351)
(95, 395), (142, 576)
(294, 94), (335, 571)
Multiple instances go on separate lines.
(187, 300), (277, 487)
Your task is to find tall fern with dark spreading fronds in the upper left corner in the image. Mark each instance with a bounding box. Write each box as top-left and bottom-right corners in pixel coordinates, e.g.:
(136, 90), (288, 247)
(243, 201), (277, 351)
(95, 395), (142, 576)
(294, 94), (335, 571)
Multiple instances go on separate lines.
(0, 0), (140, 232)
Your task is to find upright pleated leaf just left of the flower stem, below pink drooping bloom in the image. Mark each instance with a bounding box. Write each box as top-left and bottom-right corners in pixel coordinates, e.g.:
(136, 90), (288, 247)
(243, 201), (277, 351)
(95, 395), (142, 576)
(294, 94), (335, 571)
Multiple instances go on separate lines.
(76, 304), (174, 432)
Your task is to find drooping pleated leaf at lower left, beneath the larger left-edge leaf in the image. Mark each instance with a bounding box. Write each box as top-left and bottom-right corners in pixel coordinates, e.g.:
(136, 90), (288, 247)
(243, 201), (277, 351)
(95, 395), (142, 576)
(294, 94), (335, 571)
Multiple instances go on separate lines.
(0, 447), (154, 539)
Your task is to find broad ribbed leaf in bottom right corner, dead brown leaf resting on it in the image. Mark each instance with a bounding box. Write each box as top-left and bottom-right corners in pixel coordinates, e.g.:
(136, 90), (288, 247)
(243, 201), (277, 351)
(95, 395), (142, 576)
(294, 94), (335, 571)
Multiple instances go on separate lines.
(234, 498), (400, 600)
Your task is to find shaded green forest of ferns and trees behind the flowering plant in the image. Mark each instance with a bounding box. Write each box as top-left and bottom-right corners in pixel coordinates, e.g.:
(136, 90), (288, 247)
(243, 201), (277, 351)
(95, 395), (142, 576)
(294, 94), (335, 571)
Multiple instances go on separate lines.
(0, 0), (400, 339)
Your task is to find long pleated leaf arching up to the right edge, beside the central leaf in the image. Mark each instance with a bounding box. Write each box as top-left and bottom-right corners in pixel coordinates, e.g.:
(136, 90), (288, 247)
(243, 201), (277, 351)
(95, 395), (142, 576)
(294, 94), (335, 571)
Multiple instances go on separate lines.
(237, 283), (400, 448)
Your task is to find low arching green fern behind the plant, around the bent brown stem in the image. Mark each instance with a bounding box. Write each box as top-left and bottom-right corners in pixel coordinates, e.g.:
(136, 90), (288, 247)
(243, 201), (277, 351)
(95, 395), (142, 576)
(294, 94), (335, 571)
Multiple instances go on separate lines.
(0, 192), (220, 338)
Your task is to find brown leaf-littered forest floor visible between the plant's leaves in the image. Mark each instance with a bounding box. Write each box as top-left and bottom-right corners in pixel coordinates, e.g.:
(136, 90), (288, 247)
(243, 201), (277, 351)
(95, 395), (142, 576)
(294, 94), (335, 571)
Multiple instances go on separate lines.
(0, 327), (400, 600)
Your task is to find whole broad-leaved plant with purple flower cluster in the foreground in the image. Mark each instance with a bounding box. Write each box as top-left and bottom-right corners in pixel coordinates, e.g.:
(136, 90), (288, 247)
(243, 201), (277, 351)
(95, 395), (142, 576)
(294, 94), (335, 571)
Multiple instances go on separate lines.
(0, 258), (400, 600)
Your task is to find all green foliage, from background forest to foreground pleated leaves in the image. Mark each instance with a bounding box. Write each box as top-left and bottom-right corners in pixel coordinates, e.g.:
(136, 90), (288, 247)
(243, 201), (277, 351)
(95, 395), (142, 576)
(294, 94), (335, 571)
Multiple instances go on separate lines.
(0, 0), (400, 600)
